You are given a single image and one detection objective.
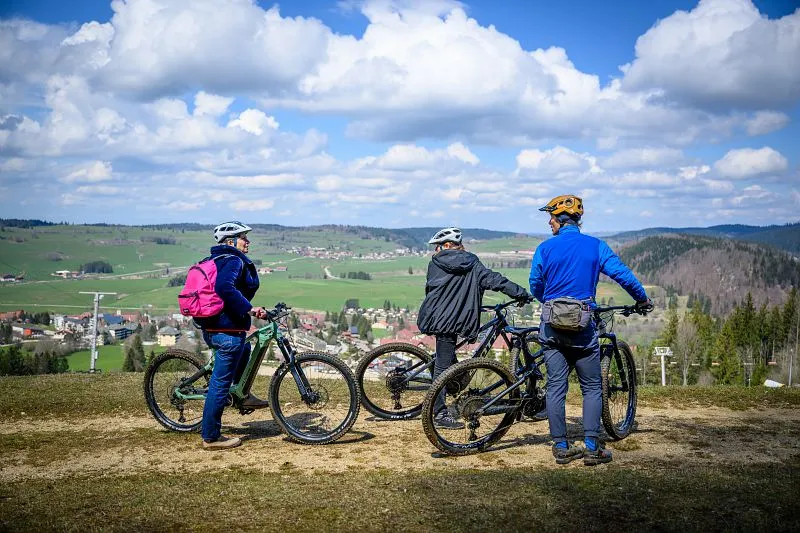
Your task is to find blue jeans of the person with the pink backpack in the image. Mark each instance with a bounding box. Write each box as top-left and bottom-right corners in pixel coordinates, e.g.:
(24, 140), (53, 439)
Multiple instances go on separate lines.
(201, 331), (250, 441)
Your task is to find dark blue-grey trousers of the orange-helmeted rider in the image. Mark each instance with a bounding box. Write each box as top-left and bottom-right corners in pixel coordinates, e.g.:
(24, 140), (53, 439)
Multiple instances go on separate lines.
(539, 323), (603, 443)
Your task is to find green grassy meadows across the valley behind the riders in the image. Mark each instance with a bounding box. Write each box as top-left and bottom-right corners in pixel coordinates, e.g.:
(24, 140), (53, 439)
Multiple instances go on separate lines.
(0, 222), (630, 314)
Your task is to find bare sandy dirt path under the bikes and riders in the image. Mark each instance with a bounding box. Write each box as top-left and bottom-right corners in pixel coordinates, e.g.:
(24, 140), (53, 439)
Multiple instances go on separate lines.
(0, 406), (800, 481)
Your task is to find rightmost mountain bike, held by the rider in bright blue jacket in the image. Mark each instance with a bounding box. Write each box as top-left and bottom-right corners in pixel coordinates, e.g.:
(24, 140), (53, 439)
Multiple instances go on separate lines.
(422, 306), (645, 455)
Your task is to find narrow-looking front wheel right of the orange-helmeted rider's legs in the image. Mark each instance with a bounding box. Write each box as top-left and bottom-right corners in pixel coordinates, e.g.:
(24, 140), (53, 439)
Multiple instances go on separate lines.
(600, 341), (636, 440)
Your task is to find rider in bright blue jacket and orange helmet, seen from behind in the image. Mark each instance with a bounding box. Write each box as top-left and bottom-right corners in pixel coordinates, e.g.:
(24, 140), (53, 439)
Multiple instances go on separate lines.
(529, 195), (653, 466)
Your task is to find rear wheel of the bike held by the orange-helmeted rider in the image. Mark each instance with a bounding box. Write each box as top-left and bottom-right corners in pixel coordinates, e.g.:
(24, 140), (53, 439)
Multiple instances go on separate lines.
(422, 358), (520, 455)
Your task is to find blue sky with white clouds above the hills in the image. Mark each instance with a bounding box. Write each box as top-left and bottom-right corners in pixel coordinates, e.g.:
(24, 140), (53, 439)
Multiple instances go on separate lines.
(0, 0), (800, 233)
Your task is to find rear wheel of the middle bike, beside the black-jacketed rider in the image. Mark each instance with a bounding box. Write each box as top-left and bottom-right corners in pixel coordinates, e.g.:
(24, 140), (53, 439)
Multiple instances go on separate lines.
(356, 342), (432, 420)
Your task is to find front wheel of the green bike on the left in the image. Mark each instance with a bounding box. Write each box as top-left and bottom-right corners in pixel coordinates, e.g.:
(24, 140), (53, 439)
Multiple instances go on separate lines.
(269, 352), (361, 444)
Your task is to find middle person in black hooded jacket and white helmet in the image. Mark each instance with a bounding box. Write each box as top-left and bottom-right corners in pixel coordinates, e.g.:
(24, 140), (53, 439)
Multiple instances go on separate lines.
(417, 228), (531, 429)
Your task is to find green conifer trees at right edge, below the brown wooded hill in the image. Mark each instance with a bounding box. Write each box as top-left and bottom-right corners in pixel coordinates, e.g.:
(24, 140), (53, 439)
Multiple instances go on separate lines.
(642, 289), (800, 385)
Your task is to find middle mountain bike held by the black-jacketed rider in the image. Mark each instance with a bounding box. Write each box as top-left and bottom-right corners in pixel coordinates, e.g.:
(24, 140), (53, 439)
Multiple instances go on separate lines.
(355, 300), (538, 420)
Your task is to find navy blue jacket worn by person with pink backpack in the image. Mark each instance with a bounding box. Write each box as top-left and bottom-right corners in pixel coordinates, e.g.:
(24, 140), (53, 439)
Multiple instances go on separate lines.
(195, 244), (259, 331)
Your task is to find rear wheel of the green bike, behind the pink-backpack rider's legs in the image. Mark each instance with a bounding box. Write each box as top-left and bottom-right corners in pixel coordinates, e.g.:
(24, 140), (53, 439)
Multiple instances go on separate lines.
(144, 348), (211, 432)
